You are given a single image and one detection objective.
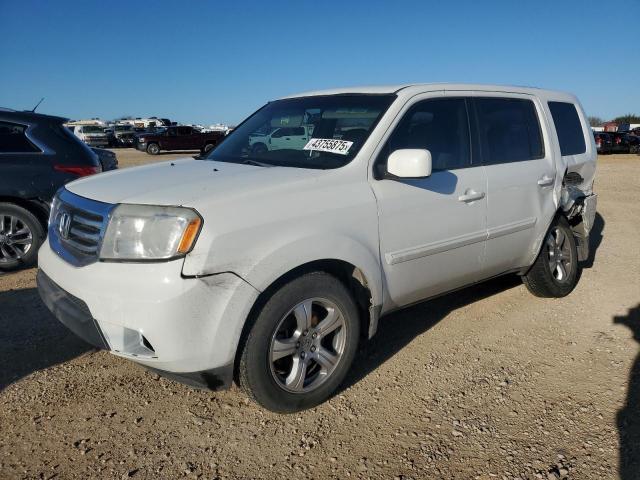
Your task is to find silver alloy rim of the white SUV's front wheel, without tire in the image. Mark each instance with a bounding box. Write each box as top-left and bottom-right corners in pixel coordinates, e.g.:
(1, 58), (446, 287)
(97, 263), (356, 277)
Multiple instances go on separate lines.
(269, 298), (347, 393)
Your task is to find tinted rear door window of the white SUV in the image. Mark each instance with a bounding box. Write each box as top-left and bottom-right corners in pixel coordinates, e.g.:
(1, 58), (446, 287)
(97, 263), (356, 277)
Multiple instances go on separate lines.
(474, 98), (544, 164)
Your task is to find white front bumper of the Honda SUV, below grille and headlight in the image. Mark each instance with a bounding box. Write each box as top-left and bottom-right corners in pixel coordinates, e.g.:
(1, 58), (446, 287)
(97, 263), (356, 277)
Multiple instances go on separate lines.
(38, 241), (259, 384)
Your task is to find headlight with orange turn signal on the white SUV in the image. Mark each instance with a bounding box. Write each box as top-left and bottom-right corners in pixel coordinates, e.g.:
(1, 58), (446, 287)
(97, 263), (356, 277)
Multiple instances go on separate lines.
(100, 204), (202, 261)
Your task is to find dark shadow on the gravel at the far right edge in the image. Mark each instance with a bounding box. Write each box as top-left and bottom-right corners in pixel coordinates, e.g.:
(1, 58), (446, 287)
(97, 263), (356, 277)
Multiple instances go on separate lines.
(613, 304), (640, 480)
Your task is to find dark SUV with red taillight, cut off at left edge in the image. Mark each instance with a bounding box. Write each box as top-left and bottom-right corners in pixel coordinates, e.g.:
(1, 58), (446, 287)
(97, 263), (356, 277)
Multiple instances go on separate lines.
(0, 109), (102, 271)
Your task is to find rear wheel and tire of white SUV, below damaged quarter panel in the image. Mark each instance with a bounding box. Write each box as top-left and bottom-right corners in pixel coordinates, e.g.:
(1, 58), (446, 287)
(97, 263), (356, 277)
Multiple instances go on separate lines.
(522, 216), (580, 298)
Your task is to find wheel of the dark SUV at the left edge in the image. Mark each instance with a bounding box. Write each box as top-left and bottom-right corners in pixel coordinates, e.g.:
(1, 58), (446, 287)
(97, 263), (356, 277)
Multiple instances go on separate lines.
(0, 203), (45, 272)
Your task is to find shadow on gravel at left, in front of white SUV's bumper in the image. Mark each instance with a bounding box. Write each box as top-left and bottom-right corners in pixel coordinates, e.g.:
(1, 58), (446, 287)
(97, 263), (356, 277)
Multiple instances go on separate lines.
(0, 288), (93, 391)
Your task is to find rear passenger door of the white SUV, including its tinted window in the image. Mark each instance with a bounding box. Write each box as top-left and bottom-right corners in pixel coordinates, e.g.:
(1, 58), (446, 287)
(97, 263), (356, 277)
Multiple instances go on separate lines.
(473, 93), (556, 277)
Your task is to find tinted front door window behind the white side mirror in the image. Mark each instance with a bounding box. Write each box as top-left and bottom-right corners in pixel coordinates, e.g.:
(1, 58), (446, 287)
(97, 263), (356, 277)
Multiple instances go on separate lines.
(382, 98), (471, 170)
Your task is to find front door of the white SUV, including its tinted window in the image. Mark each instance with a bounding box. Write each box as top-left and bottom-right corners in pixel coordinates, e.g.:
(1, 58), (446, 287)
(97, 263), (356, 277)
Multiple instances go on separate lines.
(372, 97), (487, 306)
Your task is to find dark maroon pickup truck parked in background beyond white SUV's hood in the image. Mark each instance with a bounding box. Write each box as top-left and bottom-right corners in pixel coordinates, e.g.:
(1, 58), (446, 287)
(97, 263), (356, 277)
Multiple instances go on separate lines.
(135, 126), (225, 155)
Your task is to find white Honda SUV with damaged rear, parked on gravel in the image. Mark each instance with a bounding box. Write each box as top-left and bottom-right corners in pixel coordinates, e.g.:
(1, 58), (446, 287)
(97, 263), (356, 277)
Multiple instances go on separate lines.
(38, 84), (596, 412)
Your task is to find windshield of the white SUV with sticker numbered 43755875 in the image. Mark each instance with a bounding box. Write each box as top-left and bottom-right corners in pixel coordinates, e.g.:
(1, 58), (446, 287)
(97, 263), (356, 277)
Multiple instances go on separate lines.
(207, 95), (395, 169)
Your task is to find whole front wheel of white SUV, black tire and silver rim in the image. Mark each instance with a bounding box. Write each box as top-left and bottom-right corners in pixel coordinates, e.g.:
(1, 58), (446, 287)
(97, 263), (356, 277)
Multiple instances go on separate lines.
(238, 272), (360, 413)
